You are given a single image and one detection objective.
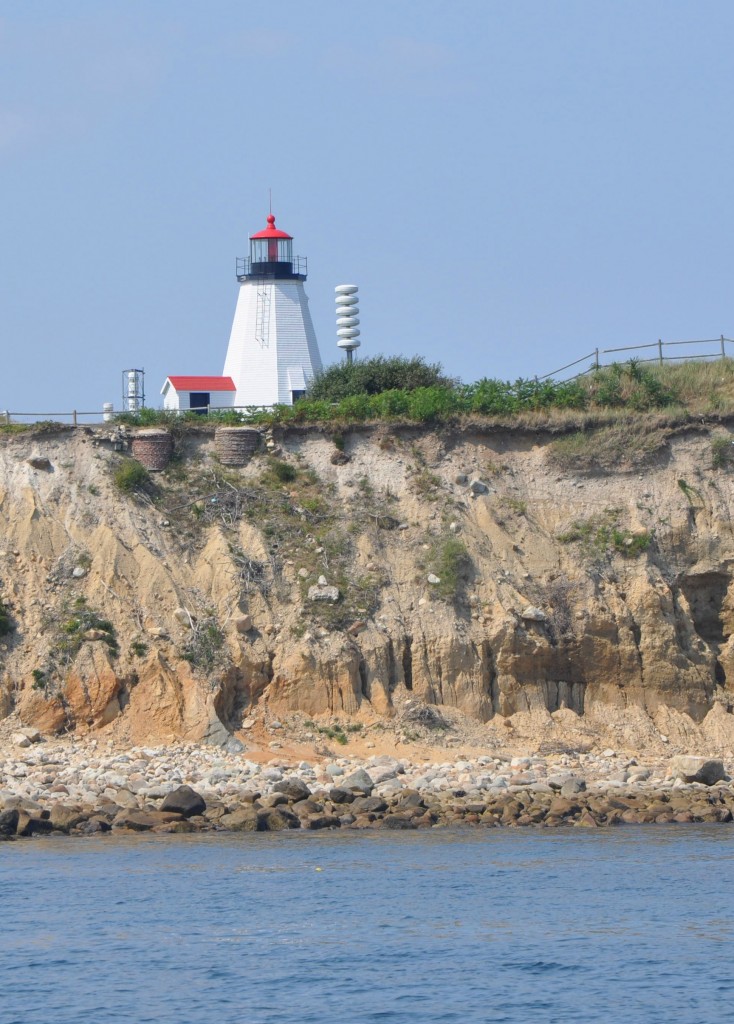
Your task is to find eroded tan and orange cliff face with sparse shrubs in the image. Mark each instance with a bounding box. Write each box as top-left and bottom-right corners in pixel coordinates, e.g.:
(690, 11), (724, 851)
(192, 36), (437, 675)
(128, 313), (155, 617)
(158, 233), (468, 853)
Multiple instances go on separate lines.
(0, 415), (734, 750)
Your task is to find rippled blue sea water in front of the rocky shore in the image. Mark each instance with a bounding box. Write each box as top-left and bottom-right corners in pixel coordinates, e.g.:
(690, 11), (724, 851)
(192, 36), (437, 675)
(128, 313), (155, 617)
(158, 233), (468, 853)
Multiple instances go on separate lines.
(0, 825), (734, 1024)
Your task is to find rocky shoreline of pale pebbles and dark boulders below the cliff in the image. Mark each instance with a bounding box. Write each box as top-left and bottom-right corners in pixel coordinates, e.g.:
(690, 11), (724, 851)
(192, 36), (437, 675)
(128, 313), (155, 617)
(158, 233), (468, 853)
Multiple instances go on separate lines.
(0, 730), (734, 840)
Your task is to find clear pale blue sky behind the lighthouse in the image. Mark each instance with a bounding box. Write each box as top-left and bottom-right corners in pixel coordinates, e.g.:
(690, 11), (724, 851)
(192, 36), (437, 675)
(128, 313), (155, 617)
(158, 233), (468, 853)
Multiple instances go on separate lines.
(0, 0), (734, 412)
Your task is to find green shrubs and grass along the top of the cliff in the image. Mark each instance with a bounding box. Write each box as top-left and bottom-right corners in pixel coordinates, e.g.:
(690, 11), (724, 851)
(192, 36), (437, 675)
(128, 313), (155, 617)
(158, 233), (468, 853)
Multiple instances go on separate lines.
(0, 356), (734, 433)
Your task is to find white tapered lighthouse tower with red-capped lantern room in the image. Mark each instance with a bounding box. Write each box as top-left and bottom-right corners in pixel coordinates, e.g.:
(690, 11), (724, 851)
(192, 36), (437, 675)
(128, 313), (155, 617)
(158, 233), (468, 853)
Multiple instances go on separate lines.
(223, 214), (321, 406)
